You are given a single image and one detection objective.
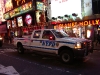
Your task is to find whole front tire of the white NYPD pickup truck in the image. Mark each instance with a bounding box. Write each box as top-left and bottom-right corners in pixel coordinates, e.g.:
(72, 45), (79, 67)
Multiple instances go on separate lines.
(60, 50), (74, 63)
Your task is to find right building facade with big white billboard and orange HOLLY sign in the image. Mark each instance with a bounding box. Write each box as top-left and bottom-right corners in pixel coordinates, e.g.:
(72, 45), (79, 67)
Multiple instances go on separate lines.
(48, 0), (100, 40)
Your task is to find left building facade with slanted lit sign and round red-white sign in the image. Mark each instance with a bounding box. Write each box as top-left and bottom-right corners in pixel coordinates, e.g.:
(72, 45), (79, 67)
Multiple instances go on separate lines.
(4, 0), (46, 37)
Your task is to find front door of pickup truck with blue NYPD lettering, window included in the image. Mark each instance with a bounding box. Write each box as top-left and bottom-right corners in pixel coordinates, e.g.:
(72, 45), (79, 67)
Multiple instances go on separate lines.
(40, 30), (56, 53)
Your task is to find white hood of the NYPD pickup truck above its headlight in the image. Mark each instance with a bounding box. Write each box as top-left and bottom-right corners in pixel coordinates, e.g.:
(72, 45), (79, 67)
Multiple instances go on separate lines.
(59, 37), (89, 42)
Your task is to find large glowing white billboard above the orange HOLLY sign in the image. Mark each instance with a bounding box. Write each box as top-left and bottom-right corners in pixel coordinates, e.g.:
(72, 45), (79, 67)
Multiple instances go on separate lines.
(51, 0), (81, 17)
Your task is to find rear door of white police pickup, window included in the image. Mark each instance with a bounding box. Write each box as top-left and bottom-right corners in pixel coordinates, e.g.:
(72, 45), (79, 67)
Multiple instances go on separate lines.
(30, 30), (41, 50)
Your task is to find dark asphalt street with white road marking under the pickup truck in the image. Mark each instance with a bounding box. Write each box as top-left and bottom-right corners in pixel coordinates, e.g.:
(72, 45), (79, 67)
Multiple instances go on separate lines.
(0, 43), (100, 75)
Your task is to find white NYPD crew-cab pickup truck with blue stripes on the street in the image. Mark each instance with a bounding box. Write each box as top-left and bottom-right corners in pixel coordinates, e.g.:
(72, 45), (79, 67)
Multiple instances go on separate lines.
(14, 29), (93, 63)
